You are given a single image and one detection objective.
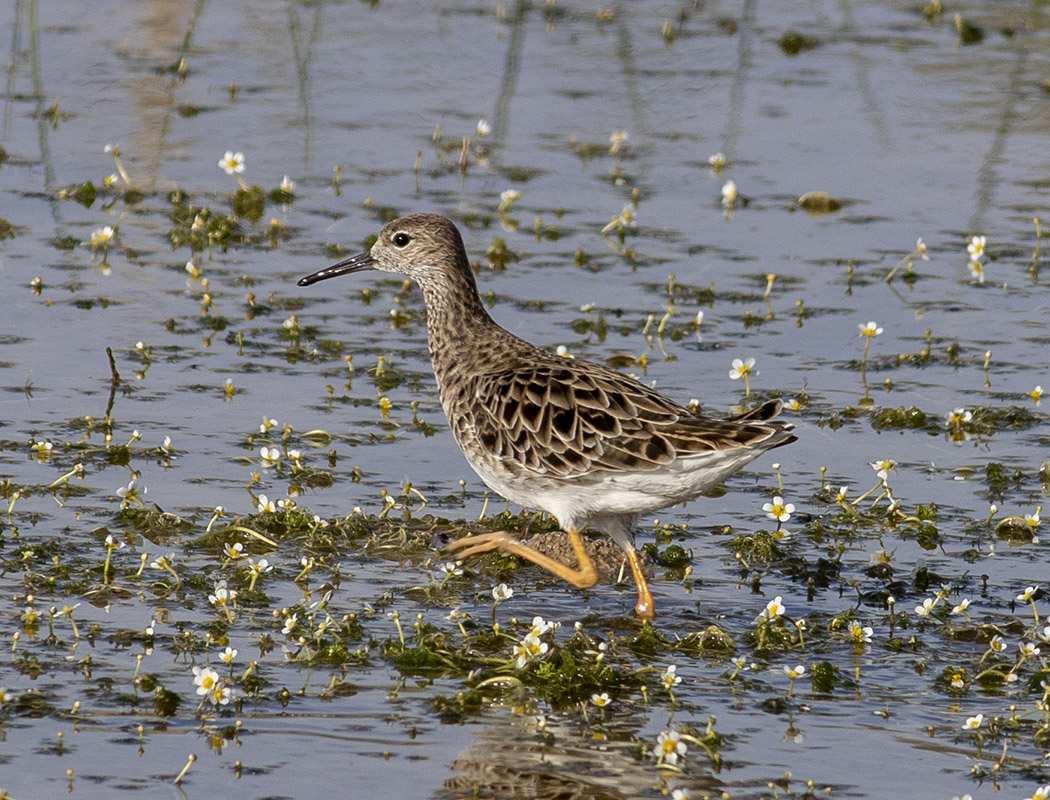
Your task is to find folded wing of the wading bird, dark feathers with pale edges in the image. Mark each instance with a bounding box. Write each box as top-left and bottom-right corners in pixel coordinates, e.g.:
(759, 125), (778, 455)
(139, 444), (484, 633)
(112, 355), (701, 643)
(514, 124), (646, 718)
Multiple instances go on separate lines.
(453, 361), (789, 478)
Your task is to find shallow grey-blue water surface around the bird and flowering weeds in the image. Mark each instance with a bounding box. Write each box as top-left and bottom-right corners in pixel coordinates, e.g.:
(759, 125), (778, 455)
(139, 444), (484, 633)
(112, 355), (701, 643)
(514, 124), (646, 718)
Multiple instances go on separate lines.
(0, 0), (1050, 798)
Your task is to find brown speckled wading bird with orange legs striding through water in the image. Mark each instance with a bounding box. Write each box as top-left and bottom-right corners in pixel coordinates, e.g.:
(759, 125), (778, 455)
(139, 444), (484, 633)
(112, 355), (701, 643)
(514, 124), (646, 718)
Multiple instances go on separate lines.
(299, 214), (796, 618)
